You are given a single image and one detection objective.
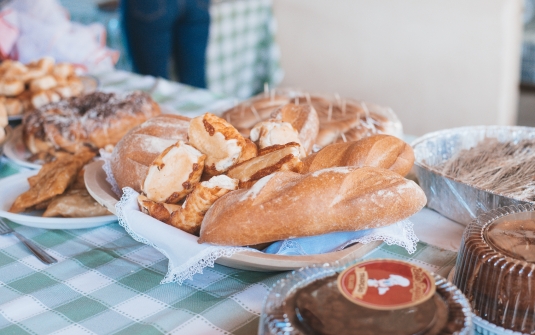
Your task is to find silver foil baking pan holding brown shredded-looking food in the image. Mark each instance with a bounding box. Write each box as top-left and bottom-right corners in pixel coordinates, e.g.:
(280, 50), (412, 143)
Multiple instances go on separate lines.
(411, 126), (535, 225)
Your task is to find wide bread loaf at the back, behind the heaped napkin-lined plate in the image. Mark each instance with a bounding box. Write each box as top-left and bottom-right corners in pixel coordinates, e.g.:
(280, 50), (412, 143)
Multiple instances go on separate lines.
(222, 91), (400, 149)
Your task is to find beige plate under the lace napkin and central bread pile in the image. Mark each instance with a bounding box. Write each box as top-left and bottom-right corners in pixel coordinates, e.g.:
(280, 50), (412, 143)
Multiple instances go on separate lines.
(84, 161), (382, 271)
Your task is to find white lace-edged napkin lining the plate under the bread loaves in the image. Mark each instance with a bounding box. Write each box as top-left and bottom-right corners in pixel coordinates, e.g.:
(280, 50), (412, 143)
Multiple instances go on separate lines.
(115, 187), (418, 284)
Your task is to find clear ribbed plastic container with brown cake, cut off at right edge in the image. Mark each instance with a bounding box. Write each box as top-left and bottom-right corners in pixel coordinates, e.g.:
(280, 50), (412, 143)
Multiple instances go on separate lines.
(453, 205), (535, 334)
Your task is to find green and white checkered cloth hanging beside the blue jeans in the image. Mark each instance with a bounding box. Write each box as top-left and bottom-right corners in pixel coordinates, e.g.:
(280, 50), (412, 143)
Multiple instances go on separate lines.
(206, 0), (282, 99)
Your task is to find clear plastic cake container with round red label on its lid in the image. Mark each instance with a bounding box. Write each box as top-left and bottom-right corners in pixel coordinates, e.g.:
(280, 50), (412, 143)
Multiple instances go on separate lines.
(259, 260), (473, 335)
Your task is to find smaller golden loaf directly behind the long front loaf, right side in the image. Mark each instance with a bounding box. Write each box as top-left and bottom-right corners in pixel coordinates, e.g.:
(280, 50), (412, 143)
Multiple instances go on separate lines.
(301, 135), (414, 176)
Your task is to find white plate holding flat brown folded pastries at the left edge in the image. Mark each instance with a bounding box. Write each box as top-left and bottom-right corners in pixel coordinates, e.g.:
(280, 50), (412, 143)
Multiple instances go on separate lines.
(0, 171), (117, 229)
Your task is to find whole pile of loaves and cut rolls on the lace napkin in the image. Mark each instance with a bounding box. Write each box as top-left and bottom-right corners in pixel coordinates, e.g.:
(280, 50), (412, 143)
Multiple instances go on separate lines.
(111, 104), (426, 246)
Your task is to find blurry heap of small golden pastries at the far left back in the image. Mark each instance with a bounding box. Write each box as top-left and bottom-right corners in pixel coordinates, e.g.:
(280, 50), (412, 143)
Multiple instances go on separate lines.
(0, 57), (84, 115)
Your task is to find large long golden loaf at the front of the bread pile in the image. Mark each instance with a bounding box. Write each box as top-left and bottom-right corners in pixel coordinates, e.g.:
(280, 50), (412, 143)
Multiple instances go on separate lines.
(199, 167), (426, 246)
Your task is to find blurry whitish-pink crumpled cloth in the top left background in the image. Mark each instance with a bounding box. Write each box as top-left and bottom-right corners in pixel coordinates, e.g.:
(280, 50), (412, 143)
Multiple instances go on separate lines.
(0, 0), (119, 71)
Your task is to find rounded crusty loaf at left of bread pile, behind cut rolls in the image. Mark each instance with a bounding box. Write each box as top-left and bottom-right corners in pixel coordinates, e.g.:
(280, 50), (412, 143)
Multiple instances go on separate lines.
(111, 114), (190, 192)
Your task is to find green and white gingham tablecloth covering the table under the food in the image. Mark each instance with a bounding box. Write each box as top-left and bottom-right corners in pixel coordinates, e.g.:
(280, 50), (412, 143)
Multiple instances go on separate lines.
(0, 72), (456, 335)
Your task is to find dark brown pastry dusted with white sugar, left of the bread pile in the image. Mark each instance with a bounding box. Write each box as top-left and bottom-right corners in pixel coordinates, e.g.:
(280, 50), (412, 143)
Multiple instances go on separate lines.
(22, 92), (160, 154)
